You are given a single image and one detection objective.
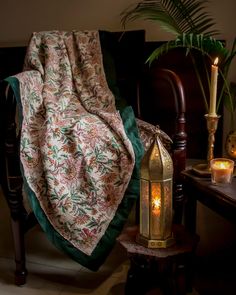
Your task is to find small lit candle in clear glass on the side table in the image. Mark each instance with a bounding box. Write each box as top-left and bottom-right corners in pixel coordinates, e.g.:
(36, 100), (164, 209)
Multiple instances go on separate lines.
(210, 158), (234, 184)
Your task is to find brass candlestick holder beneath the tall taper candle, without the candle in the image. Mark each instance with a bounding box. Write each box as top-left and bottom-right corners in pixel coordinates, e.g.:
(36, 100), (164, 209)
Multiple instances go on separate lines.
(193, 114), (220, 176)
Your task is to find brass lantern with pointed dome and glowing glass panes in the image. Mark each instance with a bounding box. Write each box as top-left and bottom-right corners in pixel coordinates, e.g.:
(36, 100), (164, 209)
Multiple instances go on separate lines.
(137, 128), (175, 248)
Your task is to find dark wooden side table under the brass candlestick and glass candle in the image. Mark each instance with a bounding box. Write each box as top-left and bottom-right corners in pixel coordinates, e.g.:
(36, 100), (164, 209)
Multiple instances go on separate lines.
(182, 169), (236, 232)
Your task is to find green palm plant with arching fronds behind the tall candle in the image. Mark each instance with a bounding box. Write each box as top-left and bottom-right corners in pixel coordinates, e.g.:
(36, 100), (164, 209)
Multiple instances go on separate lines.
(121, 0), (236, 126)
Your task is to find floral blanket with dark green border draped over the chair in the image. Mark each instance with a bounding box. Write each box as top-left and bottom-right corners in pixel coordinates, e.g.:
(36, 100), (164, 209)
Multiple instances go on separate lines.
(7, 31), (148, 270)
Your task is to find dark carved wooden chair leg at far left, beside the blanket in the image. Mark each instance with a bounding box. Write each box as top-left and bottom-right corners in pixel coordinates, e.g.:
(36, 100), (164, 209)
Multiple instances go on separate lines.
(2, 85), (28, 286)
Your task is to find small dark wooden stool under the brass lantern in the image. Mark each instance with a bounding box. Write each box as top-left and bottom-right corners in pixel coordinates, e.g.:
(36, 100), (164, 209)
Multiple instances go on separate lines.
(118, 225), (199, 295)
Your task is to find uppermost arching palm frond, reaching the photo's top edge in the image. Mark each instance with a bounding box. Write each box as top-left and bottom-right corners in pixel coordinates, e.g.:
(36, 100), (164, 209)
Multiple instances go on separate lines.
(121, 0), (218, 36)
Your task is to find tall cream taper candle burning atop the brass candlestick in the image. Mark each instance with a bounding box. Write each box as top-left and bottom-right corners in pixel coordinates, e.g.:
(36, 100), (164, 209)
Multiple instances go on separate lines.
(209, 57), (218, 117)
